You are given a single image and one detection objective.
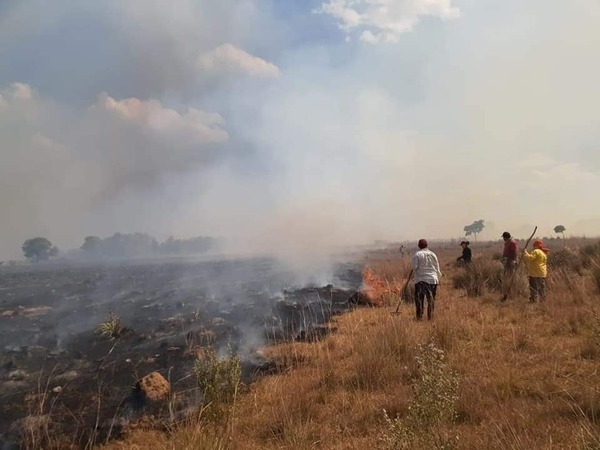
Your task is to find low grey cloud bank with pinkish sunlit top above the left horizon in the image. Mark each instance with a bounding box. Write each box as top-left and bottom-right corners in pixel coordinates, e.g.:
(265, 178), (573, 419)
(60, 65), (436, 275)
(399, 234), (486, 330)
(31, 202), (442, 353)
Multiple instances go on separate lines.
(0, 83), (228, 255)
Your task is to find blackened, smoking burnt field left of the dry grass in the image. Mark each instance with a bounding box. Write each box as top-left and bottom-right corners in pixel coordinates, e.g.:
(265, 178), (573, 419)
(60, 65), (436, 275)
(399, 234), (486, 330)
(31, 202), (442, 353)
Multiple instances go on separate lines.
(0, 255), (362, 448)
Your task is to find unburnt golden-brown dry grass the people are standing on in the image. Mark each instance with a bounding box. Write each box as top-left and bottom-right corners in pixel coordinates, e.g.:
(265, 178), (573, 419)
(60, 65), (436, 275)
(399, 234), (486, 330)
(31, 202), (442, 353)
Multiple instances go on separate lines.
(98, 242), (600, 450)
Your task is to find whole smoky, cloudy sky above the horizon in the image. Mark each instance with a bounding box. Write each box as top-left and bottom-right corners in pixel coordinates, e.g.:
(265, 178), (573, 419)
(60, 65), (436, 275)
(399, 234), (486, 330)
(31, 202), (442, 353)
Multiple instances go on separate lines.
(0, 0), (600, 259)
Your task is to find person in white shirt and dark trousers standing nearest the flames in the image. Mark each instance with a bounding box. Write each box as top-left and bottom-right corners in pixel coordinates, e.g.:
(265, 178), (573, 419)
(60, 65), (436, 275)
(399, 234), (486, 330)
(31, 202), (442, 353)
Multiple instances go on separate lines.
(412, 239), (442, 320)
